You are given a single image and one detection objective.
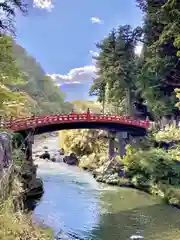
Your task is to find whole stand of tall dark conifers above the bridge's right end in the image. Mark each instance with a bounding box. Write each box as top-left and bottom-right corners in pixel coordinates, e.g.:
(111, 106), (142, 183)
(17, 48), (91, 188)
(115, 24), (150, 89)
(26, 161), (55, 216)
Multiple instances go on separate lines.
(90, 0), (180, 119)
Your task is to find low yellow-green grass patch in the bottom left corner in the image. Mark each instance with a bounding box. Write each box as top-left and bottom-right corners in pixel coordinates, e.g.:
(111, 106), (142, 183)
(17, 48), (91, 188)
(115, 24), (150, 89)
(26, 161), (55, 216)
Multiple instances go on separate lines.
(0, 197), (53, 240)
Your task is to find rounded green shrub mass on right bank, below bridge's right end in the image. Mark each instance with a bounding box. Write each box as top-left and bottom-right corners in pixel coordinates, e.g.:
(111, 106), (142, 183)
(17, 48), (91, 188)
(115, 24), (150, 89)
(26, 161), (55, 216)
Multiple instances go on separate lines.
(123, 147), (180, 186)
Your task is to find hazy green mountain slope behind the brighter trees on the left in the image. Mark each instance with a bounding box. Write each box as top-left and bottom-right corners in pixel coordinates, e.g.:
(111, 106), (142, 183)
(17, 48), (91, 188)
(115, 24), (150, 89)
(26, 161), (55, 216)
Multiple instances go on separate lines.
(13, 42), (72, 115)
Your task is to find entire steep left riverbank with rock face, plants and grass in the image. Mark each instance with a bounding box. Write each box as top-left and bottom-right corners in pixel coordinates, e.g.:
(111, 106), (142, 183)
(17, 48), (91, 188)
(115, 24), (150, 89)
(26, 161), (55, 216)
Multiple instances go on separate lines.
(0, 131), (53, 240)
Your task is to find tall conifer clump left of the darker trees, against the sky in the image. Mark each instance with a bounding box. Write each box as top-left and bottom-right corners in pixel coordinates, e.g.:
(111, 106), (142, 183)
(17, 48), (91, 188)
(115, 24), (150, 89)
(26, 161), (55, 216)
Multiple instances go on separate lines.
(90, 25), (142, 115)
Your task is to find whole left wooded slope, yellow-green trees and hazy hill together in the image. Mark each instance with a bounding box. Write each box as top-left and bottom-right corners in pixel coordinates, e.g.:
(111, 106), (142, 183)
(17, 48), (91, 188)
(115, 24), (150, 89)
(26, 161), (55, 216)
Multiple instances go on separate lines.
(0, 36), (72, 116)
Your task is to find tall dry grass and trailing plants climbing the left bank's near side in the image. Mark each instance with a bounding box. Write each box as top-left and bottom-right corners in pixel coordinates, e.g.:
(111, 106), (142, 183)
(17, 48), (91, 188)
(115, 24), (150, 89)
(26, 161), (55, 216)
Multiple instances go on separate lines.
(0, 159), (53, 240)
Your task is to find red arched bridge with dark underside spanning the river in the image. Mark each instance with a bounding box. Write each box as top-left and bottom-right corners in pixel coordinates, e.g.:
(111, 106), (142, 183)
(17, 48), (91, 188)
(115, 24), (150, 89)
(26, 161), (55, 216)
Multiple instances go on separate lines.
(4, 113), (149, 136)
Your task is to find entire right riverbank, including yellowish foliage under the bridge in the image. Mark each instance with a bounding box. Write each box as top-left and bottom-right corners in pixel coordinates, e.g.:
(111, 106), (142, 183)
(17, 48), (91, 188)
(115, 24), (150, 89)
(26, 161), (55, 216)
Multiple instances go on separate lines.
(59, 127), (180, 208)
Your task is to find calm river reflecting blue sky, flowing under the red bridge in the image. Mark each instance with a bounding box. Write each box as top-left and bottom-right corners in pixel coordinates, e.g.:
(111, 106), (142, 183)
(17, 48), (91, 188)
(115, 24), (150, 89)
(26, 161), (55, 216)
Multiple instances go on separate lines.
(33, 137), (180, 240)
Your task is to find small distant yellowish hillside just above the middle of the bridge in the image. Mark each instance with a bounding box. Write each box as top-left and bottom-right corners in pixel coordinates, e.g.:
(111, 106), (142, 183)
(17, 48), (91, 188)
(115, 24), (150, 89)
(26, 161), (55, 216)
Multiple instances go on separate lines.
(72, 100), (102, 114)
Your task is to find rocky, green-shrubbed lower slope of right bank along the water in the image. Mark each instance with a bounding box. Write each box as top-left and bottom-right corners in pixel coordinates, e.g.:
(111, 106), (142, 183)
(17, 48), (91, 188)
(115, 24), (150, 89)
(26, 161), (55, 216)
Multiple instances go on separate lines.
(80, 149), (180, 209)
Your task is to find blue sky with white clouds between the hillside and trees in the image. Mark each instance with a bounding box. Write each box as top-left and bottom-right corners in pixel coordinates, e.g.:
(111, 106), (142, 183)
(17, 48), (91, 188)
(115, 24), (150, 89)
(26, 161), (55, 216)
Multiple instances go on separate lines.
(16, 0), (142, 100)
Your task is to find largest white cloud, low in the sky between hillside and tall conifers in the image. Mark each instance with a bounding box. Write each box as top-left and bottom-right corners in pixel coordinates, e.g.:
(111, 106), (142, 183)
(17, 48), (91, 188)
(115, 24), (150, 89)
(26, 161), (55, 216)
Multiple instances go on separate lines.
(48, 65), (96, 86)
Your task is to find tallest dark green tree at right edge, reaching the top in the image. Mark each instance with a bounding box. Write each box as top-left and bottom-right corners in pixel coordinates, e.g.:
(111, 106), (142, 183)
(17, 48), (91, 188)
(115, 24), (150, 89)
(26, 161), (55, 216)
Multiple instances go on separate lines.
(136, 0), (180, 118)
